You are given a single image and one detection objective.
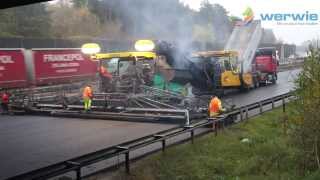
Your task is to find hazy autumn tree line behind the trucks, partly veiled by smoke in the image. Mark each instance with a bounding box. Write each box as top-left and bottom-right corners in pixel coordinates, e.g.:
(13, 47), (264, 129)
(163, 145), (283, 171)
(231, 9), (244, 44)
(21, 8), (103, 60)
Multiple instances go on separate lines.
(0, 0), (232, 46)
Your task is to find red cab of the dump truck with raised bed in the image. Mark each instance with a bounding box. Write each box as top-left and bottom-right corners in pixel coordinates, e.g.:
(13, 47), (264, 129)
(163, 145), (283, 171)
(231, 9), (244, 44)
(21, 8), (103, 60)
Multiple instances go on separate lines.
(252, 47), (279, 85)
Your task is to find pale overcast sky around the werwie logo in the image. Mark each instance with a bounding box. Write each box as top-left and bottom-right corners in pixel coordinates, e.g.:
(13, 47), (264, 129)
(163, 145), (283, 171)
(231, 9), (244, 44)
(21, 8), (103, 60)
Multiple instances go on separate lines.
(180, 0), (320, 44)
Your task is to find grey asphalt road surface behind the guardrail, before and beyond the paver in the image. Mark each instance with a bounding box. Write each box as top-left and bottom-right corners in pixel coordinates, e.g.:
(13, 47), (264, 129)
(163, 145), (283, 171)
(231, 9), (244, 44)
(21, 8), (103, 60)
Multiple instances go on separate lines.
(0, 70), (299, 179)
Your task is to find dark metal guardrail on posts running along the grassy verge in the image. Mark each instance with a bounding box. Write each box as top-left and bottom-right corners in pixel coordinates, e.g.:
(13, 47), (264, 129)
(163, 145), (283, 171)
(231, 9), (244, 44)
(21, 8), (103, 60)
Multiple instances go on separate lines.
(9, 92), (293, 180)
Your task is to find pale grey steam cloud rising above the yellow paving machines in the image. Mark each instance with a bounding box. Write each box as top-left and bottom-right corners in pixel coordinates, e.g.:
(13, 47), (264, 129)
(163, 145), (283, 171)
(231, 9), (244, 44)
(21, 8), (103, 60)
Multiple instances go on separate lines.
(104, 0), (231, 69)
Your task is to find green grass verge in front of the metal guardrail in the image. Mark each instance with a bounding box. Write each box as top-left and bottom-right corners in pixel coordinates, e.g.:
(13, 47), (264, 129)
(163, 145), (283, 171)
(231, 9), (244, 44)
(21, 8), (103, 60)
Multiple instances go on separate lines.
(106, 105), (320, 180)
